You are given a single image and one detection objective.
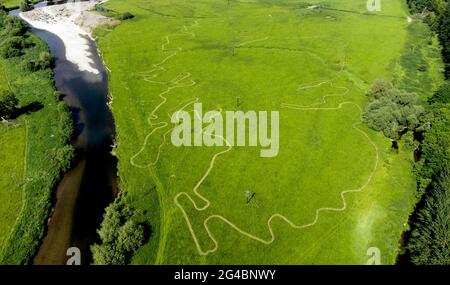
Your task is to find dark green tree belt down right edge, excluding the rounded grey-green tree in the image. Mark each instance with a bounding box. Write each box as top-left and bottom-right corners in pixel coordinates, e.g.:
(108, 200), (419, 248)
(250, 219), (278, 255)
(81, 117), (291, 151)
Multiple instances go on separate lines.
(406, 3), (450, 265)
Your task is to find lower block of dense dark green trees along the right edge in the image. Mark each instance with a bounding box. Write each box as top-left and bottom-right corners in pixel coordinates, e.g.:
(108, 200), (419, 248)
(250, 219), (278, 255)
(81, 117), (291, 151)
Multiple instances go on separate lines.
(406, 73), (450, 265)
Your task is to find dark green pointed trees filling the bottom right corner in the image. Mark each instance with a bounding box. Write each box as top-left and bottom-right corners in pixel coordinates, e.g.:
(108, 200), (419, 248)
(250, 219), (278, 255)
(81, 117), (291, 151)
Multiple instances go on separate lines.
(407, 172), (450, 265)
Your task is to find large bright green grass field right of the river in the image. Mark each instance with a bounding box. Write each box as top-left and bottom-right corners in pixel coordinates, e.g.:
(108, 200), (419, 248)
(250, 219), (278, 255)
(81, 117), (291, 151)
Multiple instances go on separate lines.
(97, 0), (442, 264)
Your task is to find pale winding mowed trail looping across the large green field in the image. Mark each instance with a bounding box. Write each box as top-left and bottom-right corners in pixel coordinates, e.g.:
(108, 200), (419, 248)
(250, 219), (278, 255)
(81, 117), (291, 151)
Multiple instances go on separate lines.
(130, 21), (379, 255)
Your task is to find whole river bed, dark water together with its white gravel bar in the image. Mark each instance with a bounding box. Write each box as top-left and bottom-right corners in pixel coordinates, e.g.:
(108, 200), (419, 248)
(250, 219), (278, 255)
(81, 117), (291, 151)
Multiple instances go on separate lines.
(19, 1), (117, 264)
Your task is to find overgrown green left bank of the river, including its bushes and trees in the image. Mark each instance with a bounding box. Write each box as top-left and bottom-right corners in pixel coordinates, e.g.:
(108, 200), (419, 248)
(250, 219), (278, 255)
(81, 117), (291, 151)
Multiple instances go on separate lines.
(0, 8), (74, 264)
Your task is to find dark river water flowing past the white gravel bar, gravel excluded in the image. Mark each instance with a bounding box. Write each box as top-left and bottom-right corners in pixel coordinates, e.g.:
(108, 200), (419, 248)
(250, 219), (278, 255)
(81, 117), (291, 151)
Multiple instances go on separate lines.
(10, 8), (117, 264)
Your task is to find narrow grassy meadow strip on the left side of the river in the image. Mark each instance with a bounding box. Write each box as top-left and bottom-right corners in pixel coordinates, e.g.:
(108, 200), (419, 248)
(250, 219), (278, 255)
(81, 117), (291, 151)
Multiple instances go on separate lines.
(0, 33), (73, 264)
